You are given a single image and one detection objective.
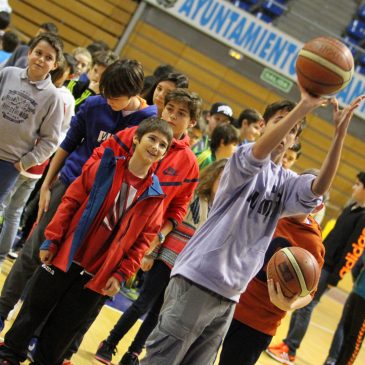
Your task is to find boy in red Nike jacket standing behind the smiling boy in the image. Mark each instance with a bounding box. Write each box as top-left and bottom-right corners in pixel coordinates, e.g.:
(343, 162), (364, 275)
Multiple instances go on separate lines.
(87, 88), (201, 364)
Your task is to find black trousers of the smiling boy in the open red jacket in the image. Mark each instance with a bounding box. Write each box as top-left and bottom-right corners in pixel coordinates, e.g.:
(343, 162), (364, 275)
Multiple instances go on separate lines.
(0, 264), (105, 365)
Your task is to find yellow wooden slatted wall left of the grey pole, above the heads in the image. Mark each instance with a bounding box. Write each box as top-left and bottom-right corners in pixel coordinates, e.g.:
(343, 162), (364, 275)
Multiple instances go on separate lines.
(9, 0), (137, 52)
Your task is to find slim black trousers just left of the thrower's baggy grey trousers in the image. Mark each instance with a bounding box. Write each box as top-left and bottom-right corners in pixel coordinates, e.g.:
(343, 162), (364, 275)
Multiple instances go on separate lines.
(108, 260), (171, 353)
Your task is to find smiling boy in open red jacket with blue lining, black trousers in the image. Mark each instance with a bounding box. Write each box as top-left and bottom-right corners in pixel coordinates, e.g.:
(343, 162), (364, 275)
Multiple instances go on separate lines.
(0, 118), (172, 365)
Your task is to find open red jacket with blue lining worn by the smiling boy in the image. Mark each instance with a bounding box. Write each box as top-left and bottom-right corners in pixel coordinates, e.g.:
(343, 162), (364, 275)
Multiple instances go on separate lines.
(41, 149), (163, 295)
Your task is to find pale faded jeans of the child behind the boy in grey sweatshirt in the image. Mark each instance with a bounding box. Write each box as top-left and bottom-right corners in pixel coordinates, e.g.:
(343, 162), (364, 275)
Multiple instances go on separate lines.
(0, 174), (38, 265)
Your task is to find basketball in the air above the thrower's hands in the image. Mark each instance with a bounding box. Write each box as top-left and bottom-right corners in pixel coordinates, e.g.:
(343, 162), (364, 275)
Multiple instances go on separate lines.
(296, 37), (354, 95)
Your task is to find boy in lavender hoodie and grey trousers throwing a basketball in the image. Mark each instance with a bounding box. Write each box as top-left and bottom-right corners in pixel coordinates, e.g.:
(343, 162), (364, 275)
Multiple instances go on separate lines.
(141, 86), (365, 365)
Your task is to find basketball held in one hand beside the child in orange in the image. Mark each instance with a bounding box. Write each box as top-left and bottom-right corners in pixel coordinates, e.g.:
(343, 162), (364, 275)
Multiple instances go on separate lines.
(266, 247), (320, 298)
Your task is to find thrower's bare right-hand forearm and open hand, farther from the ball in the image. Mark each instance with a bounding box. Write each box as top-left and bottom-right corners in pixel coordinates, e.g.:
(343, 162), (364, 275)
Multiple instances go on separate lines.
(312, 95), (365, 195)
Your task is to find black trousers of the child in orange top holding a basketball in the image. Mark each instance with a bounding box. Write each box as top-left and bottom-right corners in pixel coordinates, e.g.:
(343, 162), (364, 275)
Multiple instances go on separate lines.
(219, 319), (272, 365)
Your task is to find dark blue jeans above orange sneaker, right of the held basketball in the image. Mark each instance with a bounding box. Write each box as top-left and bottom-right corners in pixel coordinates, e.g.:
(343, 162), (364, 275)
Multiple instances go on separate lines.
(283, 269), (331, 355)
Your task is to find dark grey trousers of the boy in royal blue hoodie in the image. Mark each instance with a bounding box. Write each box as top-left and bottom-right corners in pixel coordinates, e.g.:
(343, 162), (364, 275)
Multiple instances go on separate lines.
(0, 180), (67, 318)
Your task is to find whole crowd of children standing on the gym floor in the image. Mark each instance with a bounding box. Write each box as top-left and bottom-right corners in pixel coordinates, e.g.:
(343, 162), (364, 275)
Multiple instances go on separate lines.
(0, 18), (365, 365)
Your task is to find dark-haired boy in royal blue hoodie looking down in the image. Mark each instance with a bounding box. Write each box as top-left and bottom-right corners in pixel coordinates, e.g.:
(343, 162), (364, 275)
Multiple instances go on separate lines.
(0, 59), (157, 329)
